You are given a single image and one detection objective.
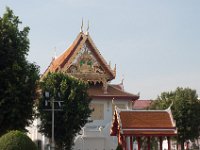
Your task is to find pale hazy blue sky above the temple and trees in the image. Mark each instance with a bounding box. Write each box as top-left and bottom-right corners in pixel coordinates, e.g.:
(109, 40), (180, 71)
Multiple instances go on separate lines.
(0, 0), (200, 99)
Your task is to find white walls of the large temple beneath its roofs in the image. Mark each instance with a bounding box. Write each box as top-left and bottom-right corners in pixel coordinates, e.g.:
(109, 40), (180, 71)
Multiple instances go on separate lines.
(27, 99), (131, 150)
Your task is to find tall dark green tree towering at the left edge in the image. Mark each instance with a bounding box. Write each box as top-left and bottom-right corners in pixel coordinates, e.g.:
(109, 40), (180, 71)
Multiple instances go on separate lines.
(0, 8), (39, 135)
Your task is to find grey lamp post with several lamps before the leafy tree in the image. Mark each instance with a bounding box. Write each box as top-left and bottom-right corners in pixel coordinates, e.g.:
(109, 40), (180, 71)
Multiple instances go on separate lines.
(45, 92), (63, 150)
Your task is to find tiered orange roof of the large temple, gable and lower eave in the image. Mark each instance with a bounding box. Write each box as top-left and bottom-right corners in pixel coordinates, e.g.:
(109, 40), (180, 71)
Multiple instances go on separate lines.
(43, 32), (139, 100)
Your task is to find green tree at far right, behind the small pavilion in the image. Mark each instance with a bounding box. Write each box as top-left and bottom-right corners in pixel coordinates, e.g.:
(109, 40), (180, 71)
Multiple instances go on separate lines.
(151, 87), (200, 149)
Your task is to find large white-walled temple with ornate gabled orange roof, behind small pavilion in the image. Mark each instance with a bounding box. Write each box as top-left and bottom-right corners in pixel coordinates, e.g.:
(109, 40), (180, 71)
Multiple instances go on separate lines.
(43, 31), (139, 150)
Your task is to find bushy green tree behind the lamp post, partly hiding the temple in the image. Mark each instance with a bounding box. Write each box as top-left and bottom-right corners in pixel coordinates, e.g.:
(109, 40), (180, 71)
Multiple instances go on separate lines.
(38, 73), (92, 150)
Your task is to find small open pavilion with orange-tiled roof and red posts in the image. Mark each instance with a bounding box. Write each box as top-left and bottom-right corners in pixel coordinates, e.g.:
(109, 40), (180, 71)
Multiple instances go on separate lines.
(110, 106), (177, 150)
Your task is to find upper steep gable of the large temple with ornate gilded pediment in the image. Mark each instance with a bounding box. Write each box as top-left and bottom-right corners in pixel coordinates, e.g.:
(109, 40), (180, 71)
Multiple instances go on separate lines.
(44, 32), (116, 83)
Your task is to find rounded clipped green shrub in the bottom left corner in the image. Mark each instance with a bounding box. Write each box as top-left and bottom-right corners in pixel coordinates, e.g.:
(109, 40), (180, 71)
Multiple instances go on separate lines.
(0, 131), (37, 150)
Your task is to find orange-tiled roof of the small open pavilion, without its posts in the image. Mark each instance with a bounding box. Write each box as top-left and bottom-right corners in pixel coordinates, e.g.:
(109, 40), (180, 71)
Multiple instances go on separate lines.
(111, 108), (177, 136)
